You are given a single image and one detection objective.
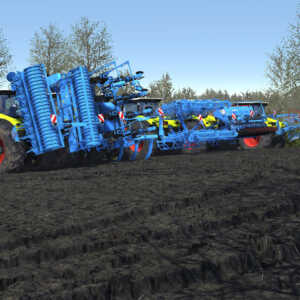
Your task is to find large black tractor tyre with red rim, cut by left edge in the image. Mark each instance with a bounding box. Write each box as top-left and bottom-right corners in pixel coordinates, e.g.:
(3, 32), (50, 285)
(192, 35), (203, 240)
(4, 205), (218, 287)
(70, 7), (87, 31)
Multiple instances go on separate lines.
(0, 120), (25, 173)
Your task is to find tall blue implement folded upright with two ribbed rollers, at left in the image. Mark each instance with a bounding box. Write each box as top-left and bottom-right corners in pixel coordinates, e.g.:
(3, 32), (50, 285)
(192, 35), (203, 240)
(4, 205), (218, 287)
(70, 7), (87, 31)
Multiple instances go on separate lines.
(1, 61), (157, 171)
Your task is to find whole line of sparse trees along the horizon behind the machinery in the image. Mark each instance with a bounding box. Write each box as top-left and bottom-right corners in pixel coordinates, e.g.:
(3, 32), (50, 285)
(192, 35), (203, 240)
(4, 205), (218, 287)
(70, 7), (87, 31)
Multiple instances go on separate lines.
(0, 13), (300, 110)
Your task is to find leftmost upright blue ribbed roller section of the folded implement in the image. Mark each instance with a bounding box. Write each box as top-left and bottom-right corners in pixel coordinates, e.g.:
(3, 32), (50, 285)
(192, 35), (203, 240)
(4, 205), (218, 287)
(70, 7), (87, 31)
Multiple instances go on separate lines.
(7, 65), (64, 155)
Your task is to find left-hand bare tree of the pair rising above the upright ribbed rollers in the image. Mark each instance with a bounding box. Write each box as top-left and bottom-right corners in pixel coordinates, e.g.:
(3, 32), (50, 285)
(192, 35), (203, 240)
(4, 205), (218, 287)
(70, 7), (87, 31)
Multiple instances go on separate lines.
(30, 24), (71, 74)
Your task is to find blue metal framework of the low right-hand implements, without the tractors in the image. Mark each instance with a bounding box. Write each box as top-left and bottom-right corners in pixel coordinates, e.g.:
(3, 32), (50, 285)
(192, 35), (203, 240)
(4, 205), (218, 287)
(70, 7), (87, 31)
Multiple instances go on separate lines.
(156, 99), (300, 151)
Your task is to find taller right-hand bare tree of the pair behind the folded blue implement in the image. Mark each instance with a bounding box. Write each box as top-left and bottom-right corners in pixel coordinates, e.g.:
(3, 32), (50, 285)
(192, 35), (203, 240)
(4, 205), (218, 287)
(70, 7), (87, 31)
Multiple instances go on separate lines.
(71, 17), (112, 71)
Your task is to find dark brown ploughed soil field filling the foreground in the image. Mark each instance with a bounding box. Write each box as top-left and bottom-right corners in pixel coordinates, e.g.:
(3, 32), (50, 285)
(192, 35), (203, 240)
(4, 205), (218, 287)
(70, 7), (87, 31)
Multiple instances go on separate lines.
(0, 148), (300, 300)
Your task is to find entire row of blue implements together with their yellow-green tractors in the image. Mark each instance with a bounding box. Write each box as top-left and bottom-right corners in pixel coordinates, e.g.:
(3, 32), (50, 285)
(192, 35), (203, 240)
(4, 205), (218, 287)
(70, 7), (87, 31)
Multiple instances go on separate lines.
(0, 61), (300, 172)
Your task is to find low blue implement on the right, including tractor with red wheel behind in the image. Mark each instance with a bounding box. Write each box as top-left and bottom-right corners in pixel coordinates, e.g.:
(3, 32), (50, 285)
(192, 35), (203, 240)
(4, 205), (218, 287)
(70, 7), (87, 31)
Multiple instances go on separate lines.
(156, 99), (300, 151)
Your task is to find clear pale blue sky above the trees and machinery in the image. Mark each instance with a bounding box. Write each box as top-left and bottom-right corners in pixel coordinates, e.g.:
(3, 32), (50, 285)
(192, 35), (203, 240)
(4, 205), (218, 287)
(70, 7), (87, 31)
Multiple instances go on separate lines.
(0, 0), (300, 93)
